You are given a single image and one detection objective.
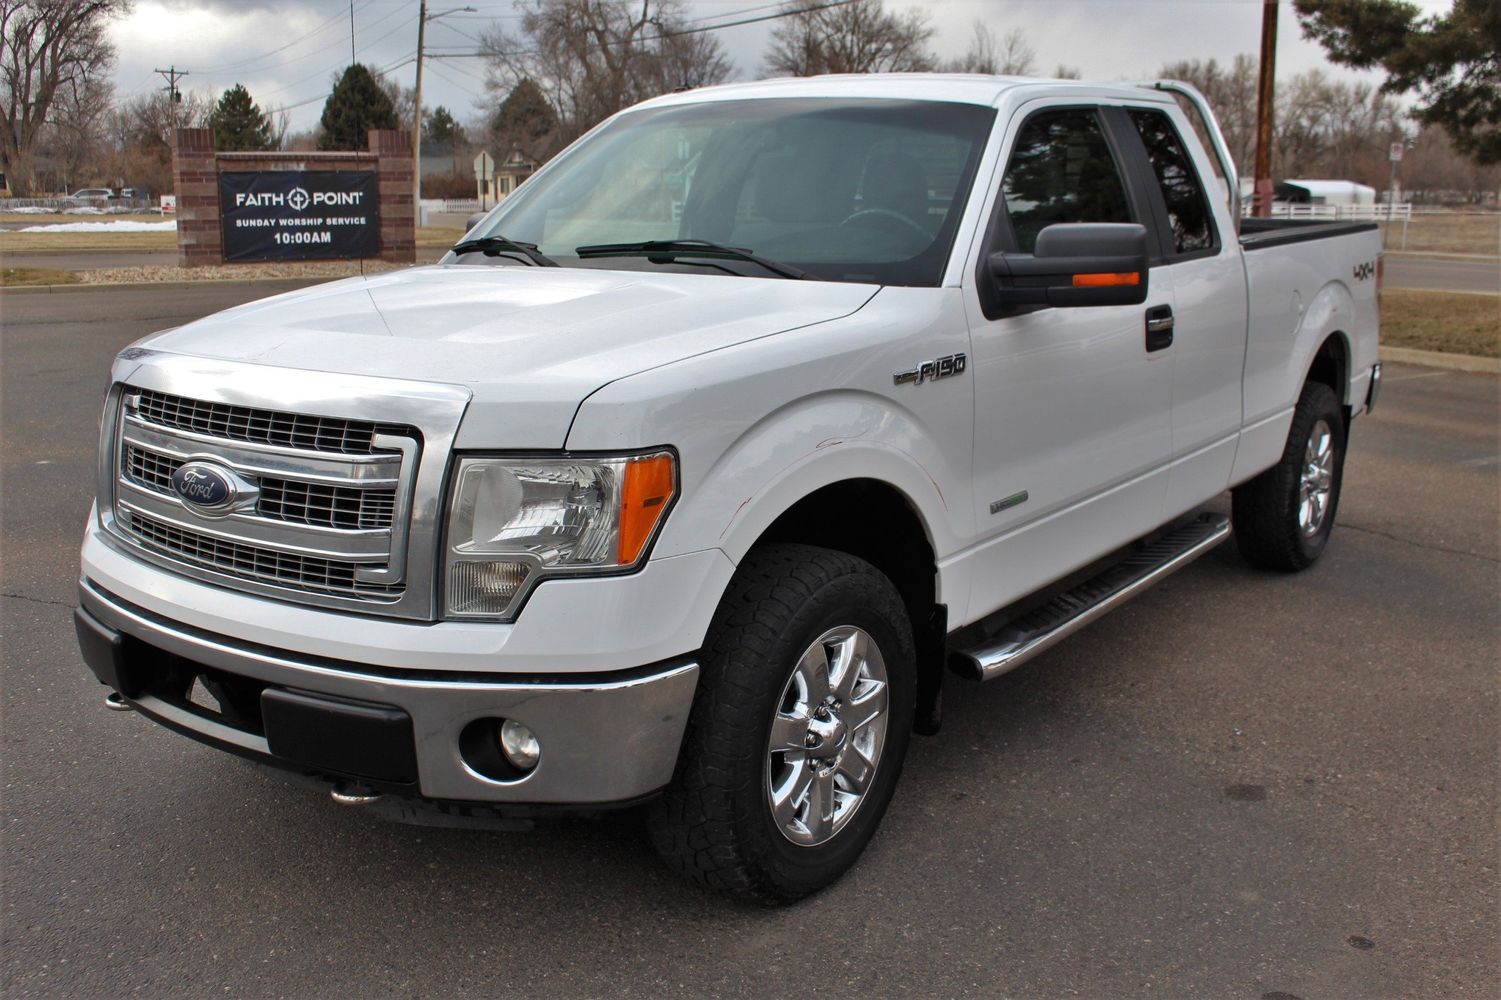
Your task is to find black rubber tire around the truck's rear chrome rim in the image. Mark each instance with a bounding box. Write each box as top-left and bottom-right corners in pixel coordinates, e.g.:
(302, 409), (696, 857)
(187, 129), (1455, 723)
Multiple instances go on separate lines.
(1231, 381), (1348, 572)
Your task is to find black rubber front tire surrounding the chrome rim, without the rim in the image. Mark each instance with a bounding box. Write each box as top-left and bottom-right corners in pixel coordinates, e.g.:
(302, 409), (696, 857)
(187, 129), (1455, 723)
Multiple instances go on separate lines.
(648, 545), (916, 905)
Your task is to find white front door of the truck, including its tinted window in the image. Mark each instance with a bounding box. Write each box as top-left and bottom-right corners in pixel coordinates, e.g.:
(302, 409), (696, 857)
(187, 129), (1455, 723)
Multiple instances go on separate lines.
(965, 105), (1172, 620)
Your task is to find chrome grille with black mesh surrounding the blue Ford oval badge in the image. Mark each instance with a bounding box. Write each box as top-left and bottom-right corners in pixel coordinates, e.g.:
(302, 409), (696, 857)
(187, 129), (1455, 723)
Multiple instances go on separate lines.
(113, 386), (420, 608)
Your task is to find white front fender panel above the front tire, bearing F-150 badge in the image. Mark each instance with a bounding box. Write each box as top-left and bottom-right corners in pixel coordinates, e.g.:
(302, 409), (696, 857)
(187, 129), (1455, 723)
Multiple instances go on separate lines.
(567, 288), (974, 600)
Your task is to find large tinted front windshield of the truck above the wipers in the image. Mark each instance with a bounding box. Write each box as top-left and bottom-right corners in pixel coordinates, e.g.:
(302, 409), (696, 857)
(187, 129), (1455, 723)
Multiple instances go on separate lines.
(465, 99), (995, 285)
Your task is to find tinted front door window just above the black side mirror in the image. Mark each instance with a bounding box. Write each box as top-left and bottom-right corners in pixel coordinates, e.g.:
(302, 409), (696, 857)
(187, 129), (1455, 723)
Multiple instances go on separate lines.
(1001, 108), (1135, 254)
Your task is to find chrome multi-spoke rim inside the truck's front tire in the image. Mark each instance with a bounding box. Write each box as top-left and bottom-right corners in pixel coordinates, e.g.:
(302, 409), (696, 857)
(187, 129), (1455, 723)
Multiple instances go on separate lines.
(766, 625), (890, 847)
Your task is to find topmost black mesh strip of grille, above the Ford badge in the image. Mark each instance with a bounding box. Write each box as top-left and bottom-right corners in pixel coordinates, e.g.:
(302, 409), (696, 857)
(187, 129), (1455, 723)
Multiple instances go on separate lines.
(137, 390), (417, 455)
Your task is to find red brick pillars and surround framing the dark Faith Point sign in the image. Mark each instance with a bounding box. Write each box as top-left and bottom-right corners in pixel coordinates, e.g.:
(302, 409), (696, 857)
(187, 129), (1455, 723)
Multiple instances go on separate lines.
(173, 129), (417, 267)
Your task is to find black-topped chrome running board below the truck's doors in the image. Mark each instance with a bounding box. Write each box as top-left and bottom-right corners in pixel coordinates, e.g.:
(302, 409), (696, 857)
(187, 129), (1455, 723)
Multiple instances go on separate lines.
(950, 514), (1229, 680)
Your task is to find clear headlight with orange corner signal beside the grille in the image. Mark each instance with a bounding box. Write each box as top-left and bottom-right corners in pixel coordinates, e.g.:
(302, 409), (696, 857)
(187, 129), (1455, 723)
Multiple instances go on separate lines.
(444, 452), (677, 619)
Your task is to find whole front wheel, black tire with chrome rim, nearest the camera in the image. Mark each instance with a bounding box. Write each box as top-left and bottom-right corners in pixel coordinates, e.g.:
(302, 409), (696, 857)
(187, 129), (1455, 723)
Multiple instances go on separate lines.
(651, 545), (916, 904)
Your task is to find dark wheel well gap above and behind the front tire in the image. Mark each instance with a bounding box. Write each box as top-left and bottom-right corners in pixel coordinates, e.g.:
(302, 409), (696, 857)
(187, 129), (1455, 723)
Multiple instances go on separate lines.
(757, 479), (947, 733)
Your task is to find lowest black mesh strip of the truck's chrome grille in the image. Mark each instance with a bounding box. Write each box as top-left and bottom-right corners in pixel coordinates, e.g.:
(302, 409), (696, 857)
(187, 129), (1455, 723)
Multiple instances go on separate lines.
(122, 511), (402, 599)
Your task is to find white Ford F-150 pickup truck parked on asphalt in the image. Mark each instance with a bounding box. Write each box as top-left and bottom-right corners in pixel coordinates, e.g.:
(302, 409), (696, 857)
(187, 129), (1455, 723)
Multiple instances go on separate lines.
(78, 75), (1379, 902)
